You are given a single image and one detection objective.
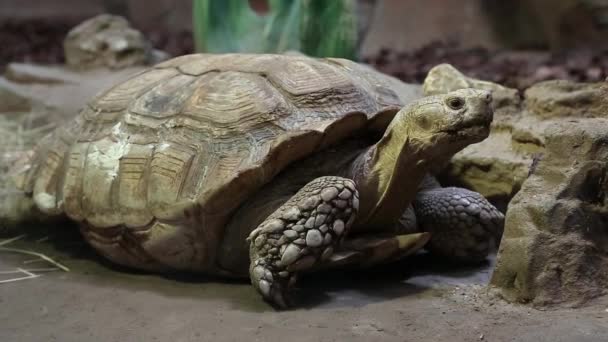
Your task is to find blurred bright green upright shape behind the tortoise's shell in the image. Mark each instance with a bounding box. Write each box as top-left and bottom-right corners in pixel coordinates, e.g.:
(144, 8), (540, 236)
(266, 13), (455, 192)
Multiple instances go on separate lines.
(194, 0), (357, 59)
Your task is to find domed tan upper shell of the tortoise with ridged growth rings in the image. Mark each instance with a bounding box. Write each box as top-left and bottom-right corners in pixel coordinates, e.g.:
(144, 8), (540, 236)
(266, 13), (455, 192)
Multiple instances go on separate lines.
(25, 54), (420, 270)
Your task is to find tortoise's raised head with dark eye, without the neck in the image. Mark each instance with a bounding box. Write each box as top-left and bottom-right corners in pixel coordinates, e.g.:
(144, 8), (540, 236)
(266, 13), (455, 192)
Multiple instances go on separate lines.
(389, 88), (493, 156)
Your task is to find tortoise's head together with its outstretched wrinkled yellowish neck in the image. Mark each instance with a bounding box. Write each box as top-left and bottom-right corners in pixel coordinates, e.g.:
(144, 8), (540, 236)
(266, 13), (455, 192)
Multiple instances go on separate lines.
(353, 89), (493, 226)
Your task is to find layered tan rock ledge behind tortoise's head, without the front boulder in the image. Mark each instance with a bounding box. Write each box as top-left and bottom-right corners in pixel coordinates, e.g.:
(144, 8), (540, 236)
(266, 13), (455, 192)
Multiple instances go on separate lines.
(423, 64), (608, 212)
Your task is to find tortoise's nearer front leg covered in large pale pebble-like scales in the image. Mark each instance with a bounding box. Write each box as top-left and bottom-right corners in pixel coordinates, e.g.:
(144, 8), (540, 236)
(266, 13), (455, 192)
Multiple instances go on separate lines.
(247, 176), (359, 308)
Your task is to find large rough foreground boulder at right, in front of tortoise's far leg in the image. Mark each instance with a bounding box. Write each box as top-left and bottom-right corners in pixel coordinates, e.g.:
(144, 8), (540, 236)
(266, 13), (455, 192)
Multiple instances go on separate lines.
(491, 119), (608, 306)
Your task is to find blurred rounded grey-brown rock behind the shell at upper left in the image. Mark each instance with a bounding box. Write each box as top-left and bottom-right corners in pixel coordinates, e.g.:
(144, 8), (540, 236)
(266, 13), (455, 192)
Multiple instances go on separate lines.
(63, 14), (166, 69)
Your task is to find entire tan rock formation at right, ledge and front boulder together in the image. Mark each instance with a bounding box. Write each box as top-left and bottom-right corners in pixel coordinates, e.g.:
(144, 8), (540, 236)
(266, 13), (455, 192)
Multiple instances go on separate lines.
(424, 65), (608, 306)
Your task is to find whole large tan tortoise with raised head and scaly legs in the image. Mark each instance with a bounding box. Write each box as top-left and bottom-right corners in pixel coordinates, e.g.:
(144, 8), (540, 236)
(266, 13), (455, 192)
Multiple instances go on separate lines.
(10, 54), (502, 307)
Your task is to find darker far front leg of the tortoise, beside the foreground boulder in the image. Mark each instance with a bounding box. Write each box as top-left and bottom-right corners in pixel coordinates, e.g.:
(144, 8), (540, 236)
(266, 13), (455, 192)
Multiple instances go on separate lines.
(414, 187), (504, 262)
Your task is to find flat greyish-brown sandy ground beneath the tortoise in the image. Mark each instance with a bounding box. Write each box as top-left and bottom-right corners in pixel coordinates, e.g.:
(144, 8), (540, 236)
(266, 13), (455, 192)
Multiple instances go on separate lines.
(0, 227), (608, 342)
